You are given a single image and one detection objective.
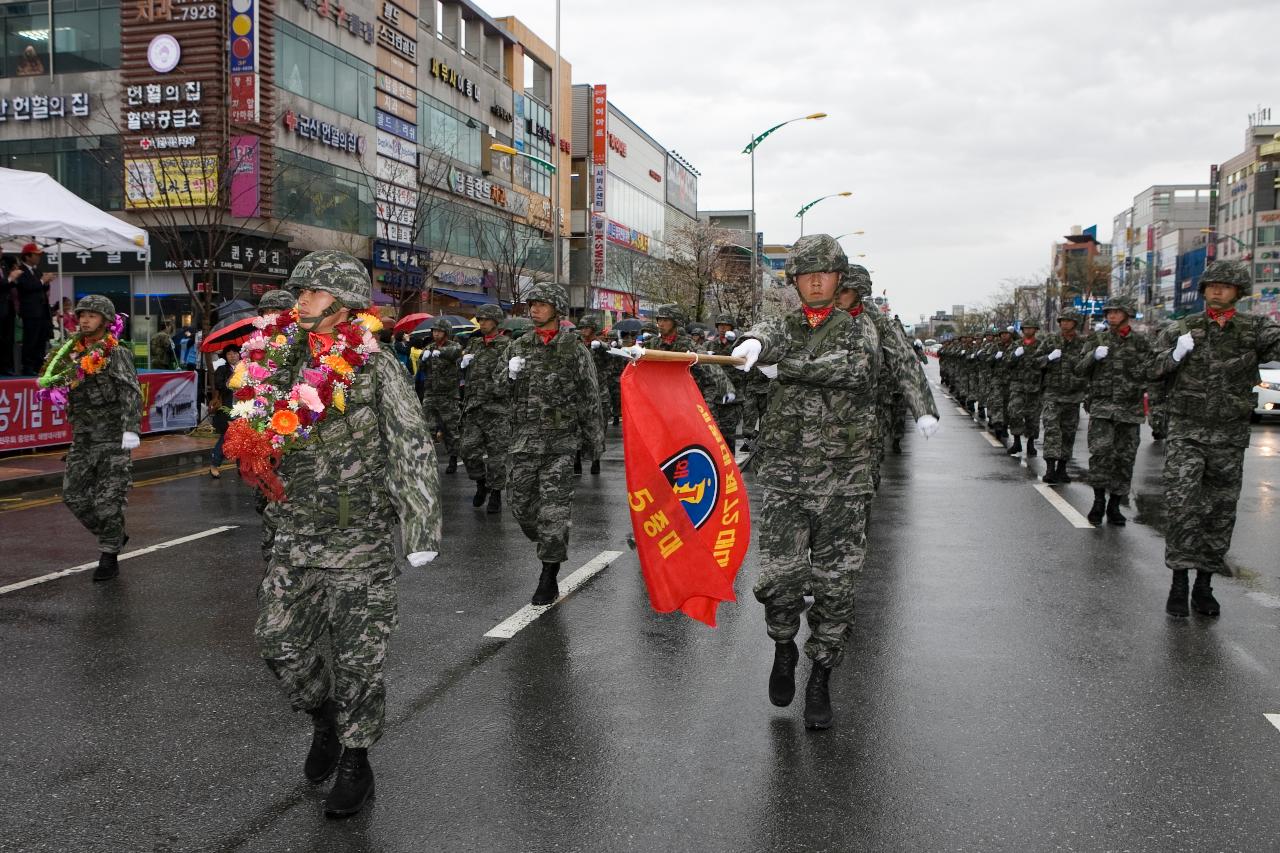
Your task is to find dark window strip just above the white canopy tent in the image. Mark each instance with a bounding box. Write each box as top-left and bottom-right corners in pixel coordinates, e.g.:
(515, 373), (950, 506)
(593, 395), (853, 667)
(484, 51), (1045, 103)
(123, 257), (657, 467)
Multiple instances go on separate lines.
(0, 136), (124, 210)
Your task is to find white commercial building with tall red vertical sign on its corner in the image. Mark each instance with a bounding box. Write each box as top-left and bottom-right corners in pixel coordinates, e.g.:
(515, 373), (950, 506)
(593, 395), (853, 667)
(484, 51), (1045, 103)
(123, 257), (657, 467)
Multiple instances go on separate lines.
(570, 85), (698, 316)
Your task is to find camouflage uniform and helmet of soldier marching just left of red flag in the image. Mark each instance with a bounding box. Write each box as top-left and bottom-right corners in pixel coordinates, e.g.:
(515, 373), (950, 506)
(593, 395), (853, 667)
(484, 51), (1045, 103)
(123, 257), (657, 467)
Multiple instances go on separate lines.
(499, 284), (604, 564)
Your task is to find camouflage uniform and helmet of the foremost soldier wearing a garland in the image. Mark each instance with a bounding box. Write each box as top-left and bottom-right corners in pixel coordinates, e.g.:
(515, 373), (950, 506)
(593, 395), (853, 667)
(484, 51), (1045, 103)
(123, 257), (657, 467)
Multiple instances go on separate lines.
(255, 251), (440, 748)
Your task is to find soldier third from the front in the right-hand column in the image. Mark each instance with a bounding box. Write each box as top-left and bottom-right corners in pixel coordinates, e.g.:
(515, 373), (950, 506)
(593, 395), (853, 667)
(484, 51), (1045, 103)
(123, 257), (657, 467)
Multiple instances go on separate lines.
(1037, 307), (1089, 483)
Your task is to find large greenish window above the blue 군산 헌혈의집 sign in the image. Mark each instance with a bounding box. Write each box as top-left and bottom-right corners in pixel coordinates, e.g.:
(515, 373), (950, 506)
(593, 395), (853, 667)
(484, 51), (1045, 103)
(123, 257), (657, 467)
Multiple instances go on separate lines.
(275, 20), (374, 124)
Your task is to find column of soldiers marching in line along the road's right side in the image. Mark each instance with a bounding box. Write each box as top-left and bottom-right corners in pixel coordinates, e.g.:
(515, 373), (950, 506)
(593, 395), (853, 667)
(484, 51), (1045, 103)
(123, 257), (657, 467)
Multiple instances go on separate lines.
(938, 261), (1280, 616)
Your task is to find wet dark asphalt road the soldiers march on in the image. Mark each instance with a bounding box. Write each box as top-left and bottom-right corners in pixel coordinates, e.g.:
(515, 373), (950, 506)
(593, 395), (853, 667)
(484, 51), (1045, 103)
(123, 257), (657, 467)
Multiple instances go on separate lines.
(0, 361), (1280, 852)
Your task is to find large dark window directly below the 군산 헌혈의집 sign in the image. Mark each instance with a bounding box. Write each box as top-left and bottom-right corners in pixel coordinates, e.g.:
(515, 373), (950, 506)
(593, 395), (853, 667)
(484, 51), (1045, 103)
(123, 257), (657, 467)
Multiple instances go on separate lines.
(275, 149), (374, 234)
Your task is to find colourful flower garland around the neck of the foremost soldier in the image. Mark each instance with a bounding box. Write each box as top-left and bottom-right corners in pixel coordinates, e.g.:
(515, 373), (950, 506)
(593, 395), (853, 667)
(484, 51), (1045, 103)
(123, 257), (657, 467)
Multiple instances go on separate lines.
(223, 310), (383, 501)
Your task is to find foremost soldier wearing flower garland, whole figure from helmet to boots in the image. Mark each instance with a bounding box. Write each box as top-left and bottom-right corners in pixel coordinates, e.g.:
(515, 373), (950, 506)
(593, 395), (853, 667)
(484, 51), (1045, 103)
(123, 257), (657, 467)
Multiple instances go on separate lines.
(247, 251), (440, 817)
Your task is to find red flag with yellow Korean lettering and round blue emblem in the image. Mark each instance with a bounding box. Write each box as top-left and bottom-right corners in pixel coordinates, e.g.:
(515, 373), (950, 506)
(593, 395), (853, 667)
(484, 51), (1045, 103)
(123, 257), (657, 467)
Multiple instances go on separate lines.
(622, 360), (751, 628)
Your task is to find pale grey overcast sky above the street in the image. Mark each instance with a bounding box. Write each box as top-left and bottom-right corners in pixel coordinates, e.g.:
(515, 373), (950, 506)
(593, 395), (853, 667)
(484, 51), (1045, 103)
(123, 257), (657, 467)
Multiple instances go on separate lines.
(485, 0), (1280, 323)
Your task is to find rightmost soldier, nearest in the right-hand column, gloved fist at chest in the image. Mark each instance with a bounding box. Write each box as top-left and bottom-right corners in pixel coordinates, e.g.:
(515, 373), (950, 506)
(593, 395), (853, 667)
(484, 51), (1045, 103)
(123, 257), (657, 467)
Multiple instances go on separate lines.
(1153, 261), (1280, 616)
